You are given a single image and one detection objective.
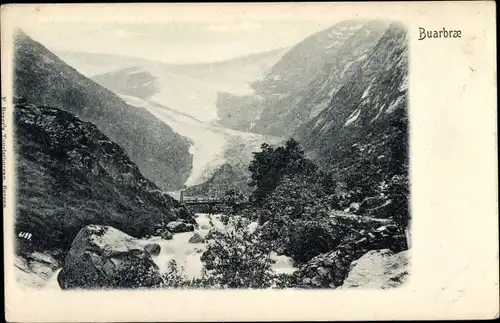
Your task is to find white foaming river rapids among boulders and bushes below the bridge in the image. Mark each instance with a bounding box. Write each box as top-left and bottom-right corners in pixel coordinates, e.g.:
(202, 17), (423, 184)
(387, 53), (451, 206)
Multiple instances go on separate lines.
(43, 213), (296, 290)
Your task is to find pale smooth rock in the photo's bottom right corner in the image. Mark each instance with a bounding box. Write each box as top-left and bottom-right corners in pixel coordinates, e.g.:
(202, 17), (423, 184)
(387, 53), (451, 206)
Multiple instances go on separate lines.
(341, 249), (409, 289)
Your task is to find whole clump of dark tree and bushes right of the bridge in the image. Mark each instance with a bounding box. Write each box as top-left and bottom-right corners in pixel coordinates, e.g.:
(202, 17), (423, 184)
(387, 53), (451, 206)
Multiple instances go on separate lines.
(249, 139), (352, 263)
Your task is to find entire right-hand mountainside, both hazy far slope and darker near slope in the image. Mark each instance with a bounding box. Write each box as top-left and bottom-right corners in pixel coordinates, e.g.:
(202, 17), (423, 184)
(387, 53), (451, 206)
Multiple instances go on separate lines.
(213, 21), (409, 215)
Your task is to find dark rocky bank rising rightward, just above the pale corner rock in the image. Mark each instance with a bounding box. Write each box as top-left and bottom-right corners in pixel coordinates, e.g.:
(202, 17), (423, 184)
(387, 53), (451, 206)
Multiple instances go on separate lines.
(293, 225), (406, 288)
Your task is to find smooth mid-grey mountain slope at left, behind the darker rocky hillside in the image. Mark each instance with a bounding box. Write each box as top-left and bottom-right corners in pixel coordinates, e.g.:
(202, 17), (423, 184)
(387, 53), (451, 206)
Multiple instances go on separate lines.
(14, 31), (192, 190)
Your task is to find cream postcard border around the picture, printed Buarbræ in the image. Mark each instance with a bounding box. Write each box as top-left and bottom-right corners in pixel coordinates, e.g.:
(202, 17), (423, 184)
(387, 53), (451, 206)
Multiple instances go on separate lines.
(1, 1), (499, 322)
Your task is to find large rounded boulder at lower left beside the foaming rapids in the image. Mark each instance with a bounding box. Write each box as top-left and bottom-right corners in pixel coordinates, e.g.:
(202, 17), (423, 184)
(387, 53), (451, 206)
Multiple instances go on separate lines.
(57, 225), (161, 289)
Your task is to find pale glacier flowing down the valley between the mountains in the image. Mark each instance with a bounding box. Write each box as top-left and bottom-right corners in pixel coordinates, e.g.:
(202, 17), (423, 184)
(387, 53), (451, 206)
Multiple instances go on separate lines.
(57, 45), (285, 186)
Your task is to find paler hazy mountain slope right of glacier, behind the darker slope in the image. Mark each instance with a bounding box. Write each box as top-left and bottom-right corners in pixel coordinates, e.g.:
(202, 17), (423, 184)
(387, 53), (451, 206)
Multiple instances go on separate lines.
(218, 20), (388, 135)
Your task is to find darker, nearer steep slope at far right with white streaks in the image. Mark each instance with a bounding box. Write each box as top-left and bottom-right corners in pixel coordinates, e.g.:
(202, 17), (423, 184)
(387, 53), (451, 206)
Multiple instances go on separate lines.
(295, 24), (408, 191)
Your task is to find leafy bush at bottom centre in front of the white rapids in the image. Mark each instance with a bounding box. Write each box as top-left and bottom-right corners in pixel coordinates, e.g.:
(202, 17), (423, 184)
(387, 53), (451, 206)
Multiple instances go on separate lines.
(201, 217), (274, 288)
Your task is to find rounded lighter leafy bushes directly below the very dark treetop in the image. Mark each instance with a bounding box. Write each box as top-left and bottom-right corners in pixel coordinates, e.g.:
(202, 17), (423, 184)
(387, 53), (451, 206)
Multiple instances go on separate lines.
(248, 167), (343, 263)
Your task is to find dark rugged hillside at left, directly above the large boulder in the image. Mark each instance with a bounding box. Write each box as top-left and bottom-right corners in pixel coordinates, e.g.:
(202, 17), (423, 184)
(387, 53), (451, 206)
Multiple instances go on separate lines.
(14, 103), (193, 253)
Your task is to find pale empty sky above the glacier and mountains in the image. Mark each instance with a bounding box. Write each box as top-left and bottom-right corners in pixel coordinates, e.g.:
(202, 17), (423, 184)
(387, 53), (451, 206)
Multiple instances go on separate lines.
(23, 20), (335, 64)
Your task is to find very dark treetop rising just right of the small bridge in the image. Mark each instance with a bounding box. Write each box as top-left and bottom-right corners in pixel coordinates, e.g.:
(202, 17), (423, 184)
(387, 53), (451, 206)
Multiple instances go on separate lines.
(248, 138), (317, 205)
